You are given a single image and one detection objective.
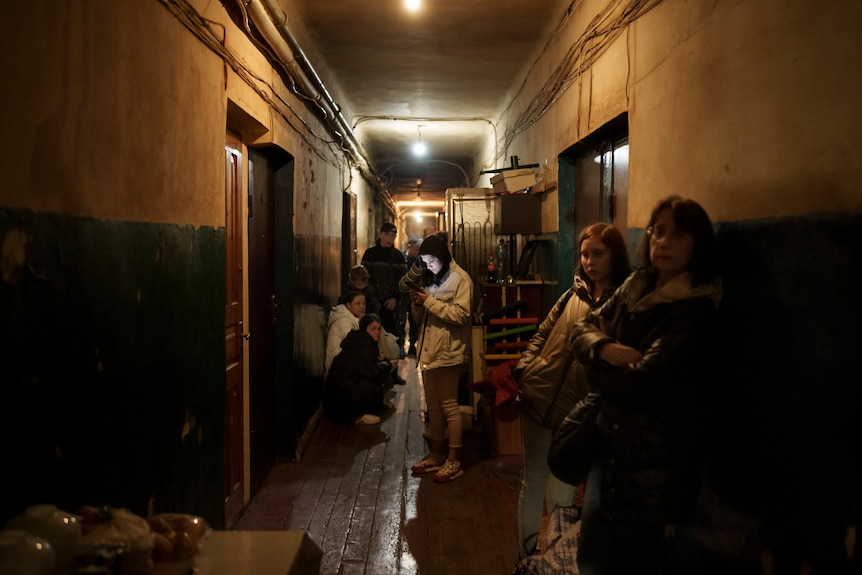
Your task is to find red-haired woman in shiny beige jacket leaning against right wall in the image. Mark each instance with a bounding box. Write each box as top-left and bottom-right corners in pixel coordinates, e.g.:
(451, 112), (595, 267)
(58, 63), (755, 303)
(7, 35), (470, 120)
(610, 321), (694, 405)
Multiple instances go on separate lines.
(512, 223), (631, 559)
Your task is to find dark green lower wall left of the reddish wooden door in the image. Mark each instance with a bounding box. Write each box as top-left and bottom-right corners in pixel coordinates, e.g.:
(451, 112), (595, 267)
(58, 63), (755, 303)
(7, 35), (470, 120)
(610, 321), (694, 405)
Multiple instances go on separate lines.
(0, 209), (225, 526)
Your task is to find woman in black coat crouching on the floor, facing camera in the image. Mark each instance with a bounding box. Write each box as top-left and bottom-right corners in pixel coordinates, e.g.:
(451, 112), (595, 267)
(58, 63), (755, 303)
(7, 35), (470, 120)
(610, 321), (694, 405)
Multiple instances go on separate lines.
(323, 314), (392, 424)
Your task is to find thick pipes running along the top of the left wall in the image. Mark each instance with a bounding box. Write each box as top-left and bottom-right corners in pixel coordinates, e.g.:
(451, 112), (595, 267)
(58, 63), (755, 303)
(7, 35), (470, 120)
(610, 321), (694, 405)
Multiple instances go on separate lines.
(245, 0), (395, 211)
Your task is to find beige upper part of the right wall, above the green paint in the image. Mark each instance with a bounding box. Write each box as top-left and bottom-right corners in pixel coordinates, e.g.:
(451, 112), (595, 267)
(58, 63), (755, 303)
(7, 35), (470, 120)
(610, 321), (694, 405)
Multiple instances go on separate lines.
(490, 0), (862, 231)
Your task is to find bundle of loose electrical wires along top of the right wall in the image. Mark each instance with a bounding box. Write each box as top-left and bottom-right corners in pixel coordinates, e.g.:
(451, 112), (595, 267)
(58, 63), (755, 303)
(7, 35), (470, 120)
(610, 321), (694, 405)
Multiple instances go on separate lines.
(496, 0), (662, 159)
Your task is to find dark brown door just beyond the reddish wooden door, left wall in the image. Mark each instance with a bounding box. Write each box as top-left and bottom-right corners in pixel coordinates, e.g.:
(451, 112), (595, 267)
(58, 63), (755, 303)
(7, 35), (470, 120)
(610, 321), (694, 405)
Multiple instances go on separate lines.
(248, 149), (279, 496)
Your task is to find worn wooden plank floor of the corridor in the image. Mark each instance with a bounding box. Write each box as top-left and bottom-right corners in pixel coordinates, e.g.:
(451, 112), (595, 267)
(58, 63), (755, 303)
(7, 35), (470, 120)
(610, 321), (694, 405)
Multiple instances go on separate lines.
(236, 358), (520, 575)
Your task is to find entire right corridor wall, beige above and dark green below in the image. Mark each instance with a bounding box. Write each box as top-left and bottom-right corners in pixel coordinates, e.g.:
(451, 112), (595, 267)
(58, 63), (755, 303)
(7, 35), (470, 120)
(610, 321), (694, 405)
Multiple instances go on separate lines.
(490, 0), (862, 573)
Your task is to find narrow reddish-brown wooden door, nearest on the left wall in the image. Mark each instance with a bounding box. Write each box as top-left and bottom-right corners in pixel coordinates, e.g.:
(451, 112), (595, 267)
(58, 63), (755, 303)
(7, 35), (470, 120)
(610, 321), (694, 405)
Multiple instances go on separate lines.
(224, 134), (245, 528)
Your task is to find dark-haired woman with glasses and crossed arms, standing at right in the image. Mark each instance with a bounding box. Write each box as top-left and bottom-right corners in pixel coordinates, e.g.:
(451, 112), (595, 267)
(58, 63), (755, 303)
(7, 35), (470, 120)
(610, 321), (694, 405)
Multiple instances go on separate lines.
(571, 196), (722, 575)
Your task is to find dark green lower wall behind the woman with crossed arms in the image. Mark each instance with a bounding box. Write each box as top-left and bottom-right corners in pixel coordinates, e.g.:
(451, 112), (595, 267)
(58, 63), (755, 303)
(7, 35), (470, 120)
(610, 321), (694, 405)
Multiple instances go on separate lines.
(559, 209), (862, 574)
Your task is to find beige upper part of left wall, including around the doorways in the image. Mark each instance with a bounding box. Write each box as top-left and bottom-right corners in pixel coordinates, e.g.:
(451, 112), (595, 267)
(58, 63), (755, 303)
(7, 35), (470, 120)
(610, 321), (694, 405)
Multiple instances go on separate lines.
(0, 0), (374, 241)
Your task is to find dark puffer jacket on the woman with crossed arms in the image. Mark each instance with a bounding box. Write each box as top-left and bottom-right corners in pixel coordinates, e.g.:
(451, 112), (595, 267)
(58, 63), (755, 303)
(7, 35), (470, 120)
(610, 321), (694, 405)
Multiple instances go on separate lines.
(572, 271), (721, 523)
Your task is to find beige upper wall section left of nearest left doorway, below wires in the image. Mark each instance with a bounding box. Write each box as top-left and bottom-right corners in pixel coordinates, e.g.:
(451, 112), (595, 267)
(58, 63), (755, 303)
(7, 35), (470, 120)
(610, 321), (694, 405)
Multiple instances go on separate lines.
(0, 0), (225, 225)
